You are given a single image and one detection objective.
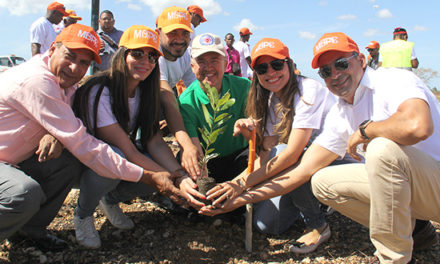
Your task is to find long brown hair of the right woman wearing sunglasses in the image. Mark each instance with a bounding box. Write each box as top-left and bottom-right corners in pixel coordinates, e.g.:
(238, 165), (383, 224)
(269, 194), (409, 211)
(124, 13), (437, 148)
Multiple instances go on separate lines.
(246, 58), (301, 151)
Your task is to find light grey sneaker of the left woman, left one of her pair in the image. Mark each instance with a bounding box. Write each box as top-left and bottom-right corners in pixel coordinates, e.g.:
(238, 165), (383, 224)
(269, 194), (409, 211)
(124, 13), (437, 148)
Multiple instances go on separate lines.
(73, 215), (101, 248)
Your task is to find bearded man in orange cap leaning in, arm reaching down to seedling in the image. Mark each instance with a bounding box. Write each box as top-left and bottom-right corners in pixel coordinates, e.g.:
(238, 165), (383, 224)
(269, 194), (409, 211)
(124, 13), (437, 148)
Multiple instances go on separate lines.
(156, 6), (201, 178)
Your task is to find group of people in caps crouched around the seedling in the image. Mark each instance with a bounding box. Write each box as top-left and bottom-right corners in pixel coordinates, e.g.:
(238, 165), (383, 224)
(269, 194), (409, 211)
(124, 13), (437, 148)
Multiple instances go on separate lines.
(0, 2), (440, 263)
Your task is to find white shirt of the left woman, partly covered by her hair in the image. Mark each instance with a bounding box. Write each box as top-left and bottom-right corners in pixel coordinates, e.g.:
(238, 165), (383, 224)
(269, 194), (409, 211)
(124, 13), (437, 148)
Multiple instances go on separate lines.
(89, 84), (141, 132)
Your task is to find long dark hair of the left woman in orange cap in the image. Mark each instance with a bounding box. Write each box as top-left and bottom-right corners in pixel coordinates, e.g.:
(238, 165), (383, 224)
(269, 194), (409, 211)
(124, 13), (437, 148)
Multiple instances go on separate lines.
(73, 47), (160, 149)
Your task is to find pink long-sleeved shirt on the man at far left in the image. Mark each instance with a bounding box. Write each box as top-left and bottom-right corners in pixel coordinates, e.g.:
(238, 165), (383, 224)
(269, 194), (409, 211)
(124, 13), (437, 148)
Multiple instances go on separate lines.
(0, 52), (143, 181)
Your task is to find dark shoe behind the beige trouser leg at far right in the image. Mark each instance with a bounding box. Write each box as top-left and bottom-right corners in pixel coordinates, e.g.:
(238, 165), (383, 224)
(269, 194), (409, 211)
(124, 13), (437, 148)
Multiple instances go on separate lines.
(412, 220), (438, 251)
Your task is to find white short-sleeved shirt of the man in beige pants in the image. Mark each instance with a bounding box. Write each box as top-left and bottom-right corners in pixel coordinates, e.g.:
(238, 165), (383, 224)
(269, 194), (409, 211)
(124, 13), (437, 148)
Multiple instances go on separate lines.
(314, 67), (440, 161)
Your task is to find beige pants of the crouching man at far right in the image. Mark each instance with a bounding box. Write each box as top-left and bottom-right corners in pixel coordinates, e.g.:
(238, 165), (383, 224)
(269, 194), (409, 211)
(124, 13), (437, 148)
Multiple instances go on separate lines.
(312, 138), (440, 263)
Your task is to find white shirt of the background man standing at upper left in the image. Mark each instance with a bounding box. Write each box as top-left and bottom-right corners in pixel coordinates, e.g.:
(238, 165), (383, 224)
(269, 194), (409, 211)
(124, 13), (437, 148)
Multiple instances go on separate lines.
(30, 17), (57, 54)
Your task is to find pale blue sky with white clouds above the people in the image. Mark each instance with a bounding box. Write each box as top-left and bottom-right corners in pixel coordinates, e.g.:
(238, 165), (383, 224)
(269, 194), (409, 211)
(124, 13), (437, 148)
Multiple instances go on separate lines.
(0, 0), (440, 89)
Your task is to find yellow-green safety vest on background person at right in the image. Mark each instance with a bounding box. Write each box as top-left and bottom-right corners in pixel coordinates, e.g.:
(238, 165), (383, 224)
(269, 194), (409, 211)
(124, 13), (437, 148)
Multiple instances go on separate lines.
(380, 39), (414, 68)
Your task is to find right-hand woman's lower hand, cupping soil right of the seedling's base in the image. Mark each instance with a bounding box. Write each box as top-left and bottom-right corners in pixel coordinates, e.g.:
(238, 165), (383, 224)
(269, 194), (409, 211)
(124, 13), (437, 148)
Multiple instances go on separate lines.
(206, 179), (244, 207)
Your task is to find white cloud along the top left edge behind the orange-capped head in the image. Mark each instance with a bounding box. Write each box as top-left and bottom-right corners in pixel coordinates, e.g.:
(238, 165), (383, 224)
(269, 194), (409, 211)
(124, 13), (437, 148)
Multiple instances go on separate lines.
(0, 0), (90, 16)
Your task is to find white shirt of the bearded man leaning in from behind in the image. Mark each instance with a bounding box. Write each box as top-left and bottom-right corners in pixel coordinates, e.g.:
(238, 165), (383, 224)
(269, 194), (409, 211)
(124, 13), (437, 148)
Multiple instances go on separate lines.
(159, 50), (196, 88)
